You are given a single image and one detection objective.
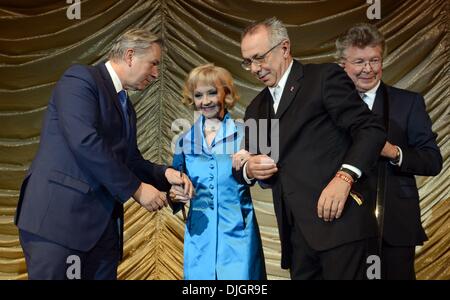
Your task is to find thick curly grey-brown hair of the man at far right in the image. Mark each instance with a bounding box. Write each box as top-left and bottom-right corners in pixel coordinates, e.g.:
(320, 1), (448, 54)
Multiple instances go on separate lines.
(335, 23), (386, 63)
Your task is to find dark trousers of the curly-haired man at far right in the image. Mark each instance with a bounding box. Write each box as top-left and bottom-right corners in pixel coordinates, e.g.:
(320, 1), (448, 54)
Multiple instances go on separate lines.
(381, 241), (416, 280)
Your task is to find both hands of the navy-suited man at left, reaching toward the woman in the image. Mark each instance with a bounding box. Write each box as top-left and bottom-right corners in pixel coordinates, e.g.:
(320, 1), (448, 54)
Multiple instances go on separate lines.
(133, 168), (194, 211)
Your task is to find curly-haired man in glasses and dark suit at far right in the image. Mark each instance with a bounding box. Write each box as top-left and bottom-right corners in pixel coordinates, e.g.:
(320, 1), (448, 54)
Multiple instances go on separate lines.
(336, 23), (442, 279)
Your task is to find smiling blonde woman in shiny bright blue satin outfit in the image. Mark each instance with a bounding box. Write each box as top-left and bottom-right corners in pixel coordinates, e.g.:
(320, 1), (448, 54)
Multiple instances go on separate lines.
(170, 64), (266, 280)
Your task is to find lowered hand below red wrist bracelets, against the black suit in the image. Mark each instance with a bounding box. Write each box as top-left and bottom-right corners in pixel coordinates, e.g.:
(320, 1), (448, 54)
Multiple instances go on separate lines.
(317, 177), (351, 222)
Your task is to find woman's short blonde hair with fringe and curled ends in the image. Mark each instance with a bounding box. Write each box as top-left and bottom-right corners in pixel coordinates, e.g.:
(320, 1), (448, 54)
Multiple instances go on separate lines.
(182, 64), (239, 109)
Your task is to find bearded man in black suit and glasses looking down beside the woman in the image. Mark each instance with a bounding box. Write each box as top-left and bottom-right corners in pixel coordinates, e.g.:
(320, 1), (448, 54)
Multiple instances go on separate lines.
(235, 18), (385, 279)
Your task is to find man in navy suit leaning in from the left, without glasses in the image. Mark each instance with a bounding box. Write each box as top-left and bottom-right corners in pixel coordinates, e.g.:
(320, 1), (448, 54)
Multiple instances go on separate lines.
(15, 29), (192, 279)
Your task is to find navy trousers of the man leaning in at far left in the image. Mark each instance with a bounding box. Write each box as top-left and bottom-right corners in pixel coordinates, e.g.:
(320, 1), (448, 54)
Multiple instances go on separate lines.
(19, 219), (120, 280)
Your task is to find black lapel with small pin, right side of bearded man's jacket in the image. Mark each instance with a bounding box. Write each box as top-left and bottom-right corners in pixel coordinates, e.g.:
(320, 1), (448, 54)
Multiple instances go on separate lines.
(275, 60), (303, 119)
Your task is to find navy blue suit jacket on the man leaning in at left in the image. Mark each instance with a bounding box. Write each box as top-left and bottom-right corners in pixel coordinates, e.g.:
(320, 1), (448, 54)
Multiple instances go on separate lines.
(15, 63), (170, 251)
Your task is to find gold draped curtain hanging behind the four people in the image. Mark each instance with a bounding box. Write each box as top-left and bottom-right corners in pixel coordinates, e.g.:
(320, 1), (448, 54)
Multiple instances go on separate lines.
(0, 0), (450, 279)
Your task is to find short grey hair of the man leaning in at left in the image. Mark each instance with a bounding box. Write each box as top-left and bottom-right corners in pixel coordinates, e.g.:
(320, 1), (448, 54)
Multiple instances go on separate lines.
(108, 28), (163, 61)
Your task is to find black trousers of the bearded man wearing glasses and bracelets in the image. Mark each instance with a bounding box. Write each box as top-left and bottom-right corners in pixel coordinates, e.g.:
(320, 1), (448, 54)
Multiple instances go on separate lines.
(290, 226), (376, 280)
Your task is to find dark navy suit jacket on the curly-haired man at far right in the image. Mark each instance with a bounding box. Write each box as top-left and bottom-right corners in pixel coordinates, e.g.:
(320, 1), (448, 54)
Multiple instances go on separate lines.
(373, 82), (442, 247)
